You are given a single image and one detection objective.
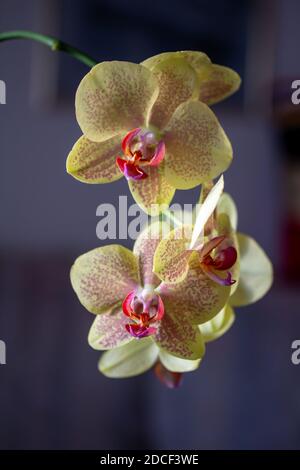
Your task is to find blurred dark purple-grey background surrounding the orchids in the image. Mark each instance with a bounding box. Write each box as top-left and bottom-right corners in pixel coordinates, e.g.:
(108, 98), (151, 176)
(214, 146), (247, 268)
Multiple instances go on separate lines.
(0, 0), (300, 450)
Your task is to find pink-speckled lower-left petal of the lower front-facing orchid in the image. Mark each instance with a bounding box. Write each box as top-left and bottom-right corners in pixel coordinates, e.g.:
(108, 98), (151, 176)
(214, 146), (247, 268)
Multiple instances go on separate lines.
(88, 305), (132, 351)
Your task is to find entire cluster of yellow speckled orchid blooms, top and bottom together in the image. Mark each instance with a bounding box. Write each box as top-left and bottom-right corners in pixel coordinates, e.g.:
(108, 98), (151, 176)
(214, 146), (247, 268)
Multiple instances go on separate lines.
(67, 51), (272, 387)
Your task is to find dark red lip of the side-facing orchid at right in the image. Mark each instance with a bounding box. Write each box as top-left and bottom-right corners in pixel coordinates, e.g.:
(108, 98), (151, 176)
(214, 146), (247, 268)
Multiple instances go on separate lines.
(199, 236), (237, 286)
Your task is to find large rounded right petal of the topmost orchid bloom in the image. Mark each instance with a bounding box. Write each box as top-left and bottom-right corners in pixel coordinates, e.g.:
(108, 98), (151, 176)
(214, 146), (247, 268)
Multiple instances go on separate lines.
(164, 101), (232, 189)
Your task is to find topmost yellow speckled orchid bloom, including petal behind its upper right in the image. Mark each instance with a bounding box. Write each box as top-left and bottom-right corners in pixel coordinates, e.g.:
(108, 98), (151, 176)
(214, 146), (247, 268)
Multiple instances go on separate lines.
(67, 52), (240, 215)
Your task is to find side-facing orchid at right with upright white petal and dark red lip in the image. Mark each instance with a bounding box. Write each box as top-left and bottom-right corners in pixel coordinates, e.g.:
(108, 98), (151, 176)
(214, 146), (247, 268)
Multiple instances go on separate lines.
(153, 177), (273, 306)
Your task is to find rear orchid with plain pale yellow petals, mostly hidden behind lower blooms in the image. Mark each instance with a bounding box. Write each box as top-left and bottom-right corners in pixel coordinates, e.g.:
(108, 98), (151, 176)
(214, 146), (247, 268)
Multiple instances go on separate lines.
(95, 193), (273, 388)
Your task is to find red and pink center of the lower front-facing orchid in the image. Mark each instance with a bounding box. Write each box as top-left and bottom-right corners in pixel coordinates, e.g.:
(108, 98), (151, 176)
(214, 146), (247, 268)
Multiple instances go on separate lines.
(122, 291), (164, 338)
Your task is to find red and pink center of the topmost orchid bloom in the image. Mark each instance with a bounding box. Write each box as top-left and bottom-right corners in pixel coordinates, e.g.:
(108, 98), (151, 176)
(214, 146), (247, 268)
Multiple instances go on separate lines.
(116, 128), (165, 180)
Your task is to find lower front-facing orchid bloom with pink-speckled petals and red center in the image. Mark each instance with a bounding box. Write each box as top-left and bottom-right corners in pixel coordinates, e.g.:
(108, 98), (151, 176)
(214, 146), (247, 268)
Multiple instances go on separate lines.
(71, 222), (230, 374)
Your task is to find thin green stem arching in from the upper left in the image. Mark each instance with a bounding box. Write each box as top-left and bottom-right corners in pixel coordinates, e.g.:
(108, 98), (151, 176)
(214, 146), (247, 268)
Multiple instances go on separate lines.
(0, 30), (98, 67)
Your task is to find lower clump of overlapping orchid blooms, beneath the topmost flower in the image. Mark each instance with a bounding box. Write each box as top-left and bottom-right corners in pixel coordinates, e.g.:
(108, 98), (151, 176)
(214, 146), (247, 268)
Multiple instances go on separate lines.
(71, 179), (271, 387)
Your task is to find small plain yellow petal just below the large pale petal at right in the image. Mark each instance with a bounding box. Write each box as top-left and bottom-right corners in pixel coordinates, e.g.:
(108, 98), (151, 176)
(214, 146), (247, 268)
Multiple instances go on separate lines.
(199, 304), (235, 343)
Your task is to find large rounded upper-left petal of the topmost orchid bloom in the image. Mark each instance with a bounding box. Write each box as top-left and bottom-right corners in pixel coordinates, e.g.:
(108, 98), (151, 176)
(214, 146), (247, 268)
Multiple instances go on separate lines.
(75, 61), (159, 142)
